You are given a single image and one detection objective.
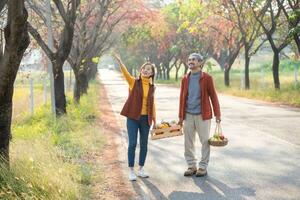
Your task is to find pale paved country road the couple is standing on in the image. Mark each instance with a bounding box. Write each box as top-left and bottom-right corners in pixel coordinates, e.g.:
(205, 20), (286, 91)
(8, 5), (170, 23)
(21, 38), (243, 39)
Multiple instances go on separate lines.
(100, 69), (300, 200)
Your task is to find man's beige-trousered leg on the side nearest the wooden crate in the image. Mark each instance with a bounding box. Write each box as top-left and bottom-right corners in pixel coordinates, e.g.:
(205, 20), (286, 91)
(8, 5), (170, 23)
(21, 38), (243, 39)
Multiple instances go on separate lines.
(183, 113), (197, 168)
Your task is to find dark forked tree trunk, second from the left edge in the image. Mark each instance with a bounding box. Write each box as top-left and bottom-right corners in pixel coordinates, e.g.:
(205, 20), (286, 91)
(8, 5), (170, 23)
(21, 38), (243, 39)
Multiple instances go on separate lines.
(29, 0), (80, 116)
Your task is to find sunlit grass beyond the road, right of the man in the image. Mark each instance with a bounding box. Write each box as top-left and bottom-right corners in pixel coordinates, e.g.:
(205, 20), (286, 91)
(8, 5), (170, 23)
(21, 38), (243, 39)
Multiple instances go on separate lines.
(212, 60), (300, 107)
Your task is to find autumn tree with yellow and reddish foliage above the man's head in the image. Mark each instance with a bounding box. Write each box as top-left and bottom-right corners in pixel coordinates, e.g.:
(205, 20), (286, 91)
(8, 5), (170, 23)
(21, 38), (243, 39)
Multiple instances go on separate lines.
(179, 0), (242, 86)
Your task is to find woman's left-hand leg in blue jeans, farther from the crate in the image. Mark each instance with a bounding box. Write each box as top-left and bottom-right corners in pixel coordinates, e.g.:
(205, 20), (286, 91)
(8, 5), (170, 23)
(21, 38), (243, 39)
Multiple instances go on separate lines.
(127, 118), (139, 168)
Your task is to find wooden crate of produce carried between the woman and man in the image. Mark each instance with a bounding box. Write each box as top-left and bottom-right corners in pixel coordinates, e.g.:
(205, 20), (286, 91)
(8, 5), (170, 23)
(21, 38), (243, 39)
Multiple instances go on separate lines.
(151, 125), (183, 140)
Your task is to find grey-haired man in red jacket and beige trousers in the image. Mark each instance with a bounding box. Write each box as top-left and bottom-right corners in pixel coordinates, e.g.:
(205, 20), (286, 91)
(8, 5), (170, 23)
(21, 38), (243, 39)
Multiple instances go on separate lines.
(178, 53), (221, 176)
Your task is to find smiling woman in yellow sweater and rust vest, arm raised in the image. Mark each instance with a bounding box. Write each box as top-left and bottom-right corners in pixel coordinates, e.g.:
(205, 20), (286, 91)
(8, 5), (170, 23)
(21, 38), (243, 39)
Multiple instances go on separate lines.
(114, 55), (156, 181)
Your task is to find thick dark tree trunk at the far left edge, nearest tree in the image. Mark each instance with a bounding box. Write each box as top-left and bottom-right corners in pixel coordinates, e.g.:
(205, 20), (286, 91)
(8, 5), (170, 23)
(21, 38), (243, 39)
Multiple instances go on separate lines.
(0, 0), (30, 164)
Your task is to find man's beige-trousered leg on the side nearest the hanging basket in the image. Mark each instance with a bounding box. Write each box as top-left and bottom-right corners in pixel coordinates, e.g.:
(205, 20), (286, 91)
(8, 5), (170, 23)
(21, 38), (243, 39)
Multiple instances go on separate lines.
(195, 115), (211, 169)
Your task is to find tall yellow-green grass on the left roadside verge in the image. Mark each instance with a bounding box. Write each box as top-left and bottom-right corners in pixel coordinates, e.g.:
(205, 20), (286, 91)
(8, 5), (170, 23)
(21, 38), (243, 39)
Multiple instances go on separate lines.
(0, 83), (105, 199)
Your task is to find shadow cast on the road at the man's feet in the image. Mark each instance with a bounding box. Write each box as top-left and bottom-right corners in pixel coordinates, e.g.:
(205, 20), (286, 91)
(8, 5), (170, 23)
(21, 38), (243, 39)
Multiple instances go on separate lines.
(168, 176), (255, 200)
